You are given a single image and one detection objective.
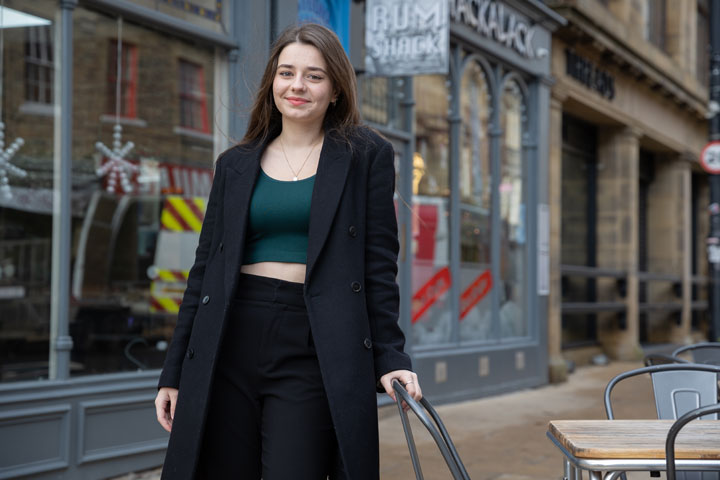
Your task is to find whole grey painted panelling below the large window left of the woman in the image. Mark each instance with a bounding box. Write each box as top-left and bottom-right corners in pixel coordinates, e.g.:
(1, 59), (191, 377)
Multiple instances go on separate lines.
(0, 376), (168, 480)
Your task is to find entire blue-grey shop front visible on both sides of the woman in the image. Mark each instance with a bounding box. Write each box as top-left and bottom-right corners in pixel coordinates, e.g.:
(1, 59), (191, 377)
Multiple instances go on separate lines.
(0, 0), (562, 479)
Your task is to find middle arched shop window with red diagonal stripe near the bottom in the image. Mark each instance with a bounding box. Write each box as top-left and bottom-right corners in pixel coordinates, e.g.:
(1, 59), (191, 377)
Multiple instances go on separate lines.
(459, 61), (492, 340)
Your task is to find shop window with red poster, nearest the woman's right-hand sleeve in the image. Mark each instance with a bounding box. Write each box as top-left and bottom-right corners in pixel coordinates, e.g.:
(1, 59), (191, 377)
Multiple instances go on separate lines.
(412, 75), (451, 345)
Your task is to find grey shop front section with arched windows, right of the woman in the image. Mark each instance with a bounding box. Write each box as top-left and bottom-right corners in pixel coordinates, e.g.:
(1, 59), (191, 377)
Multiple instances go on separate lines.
(372, 0), (563, 401)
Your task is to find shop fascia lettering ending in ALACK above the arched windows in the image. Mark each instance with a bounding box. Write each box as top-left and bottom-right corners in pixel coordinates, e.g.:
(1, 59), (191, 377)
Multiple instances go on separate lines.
(449, 0), (548, 59)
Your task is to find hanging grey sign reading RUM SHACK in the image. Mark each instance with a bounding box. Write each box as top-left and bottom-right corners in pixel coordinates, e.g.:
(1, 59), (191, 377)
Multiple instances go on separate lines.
(365, 0), (450, 76)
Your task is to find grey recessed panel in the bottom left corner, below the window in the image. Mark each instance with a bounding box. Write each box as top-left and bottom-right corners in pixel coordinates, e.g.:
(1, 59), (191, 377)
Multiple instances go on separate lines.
(0, 403), (71, 479)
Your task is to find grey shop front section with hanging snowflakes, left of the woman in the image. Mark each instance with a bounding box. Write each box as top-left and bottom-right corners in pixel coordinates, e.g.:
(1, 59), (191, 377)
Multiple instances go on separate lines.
(0, 0), (248, 478)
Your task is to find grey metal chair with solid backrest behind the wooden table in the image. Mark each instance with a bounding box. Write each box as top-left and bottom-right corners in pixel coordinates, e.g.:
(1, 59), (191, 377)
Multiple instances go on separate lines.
(605, 363), (720, 480)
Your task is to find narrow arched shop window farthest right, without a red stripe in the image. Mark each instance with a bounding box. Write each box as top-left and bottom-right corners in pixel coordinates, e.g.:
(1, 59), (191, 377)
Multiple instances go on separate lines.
(495, 80), (527, 337)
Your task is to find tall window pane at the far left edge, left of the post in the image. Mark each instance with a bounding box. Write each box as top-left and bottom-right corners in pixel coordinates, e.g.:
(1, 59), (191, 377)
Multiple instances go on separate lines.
(0, 0), (56, 382)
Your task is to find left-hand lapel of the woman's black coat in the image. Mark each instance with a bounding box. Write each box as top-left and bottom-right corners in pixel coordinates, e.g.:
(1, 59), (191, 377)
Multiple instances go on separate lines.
(223, 144), (265, 302)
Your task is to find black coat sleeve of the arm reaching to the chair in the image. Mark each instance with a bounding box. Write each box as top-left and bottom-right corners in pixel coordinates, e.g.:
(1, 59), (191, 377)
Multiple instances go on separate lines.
(365, 138), (412, 391)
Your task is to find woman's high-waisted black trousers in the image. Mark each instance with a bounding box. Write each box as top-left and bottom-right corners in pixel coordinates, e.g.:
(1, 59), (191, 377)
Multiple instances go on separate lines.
(198, 273), (338, 480)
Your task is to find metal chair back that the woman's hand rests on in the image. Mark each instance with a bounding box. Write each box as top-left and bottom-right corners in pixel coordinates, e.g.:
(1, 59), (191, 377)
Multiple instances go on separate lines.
(393, 380), (470, 480)
